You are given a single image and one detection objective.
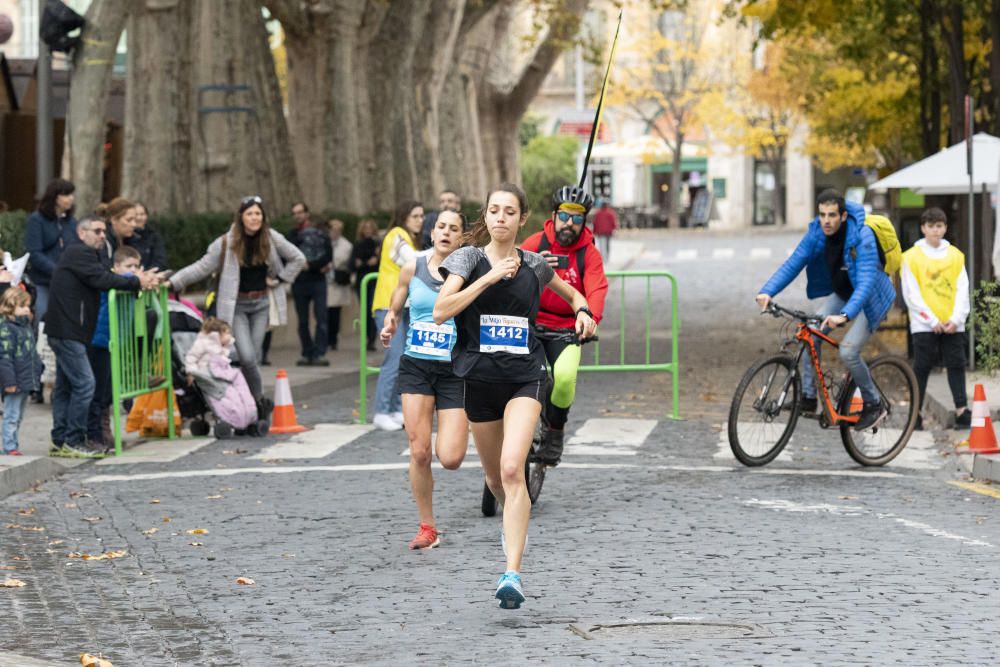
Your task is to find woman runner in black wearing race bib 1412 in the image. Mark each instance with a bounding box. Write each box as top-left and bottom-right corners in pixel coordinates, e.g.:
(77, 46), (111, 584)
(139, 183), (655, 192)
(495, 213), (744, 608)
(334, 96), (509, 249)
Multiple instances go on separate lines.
(434, 183), (597, 609)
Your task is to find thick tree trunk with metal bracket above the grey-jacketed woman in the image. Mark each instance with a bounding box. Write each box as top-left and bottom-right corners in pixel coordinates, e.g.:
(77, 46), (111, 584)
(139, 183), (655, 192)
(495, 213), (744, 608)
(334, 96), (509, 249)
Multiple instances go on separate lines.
(124, 0), (300, 214)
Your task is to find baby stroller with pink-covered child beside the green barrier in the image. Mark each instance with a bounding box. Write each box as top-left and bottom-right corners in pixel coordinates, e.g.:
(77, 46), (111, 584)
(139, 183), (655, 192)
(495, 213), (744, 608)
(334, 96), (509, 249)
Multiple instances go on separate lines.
(167, 300), (269, 439)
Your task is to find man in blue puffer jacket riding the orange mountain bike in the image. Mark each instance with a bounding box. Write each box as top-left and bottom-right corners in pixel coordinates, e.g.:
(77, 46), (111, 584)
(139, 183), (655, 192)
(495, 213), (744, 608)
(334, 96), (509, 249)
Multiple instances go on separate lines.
(757, 190), (896, 431)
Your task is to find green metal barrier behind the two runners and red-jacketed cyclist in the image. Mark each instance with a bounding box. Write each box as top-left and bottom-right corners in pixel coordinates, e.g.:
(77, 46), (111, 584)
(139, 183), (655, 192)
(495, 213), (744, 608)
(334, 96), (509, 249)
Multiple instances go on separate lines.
(354, 271), (681, 424)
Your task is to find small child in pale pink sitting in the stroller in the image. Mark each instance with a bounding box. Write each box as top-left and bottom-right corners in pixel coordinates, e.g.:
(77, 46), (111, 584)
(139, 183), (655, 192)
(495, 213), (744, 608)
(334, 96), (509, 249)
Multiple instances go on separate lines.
(184, 317), (268, 438)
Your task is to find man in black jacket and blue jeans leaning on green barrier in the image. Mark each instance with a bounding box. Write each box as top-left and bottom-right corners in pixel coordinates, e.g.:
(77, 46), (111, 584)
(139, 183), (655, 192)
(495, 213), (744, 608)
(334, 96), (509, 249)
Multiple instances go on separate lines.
(45, 216), (159, 458)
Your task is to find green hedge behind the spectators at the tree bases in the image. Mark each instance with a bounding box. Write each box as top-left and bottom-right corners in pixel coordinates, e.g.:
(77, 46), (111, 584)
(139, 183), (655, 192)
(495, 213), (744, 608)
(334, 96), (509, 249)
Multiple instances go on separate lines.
(0, 202), (547, 280)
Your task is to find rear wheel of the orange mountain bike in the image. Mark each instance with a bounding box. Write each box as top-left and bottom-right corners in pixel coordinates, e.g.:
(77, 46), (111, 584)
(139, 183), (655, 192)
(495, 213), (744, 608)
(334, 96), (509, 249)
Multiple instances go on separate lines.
(837, 356), (920, 466)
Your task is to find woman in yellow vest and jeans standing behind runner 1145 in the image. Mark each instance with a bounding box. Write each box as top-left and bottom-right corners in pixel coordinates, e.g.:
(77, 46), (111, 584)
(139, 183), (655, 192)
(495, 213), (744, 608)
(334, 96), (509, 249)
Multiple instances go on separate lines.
(372, 201), (424, 431)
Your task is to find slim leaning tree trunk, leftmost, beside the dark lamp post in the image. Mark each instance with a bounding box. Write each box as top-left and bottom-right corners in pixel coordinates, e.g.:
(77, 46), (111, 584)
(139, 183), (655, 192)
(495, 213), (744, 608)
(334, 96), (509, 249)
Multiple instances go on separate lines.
(66, 0), (129, 213)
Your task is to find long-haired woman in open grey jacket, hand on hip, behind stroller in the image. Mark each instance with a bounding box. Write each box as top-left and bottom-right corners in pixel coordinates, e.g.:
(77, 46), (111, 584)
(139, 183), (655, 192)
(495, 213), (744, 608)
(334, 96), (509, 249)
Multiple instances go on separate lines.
(170, 196), (306, 410)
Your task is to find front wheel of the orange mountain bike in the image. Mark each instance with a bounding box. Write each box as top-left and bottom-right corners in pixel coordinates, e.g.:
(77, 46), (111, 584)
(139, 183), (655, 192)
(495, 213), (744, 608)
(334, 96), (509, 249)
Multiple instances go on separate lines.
(729, 355), (802, 466)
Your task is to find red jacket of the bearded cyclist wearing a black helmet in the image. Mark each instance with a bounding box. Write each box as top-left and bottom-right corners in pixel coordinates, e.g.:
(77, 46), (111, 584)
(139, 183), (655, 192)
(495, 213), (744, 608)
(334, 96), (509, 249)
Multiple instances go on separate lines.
(521, 220), (608, 329)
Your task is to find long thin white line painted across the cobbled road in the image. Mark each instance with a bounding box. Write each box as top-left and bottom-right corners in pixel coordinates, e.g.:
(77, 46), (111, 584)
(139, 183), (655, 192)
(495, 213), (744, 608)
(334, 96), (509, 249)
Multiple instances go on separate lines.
(83, 461), (905, 484)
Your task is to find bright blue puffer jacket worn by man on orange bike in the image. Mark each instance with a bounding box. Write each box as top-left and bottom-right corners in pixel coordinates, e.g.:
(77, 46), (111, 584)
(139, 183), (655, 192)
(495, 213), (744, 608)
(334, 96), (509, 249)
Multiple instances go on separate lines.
(759, 202), (896, 331)
